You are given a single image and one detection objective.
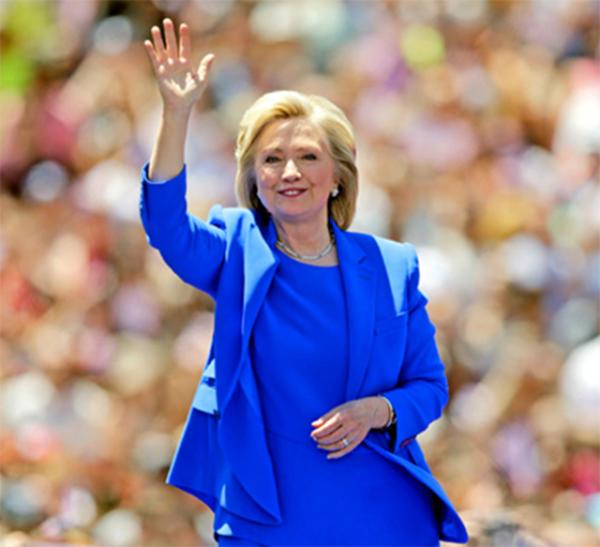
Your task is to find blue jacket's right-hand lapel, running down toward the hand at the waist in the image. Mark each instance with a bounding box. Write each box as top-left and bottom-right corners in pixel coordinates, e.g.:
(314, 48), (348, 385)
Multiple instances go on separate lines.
(331, 222), (376, 401)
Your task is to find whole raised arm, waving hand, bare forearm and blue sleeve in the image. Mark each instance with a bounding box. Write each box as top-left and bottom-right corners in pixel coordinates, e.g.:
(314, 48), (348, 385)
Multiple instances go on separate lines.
(140, 19), (226, 297)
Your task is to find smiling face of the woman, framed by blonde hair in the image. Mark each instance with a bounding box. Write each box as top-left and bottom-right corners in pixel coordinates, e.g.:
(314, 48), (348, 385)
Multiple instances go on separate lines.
(254, 118), (337, 228)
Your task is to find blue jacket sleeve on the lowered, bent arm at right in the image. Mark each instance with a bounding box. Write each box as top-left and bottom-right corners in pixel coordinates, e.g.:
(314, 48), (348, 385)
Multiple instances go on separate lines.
(382, 244), (448, 452)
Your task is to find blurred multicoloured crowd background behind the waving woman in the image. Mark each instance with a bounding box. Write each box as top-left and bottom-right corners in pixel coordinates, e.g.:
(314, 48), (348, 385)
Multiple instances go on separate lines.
(0, 0), (600, 547)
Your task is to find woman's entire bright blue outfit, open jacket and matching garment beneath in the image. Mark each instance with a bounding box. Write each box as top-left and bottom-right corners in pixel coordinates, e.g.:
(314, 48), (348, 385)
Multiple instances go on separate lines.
(140, 162), (468, 545)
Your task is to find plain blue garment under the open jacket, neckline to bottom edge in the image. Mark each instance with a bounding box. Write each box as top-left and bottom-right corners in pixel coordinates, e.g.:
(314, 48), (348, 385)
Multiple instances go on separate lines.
(215, 250), (439, 545)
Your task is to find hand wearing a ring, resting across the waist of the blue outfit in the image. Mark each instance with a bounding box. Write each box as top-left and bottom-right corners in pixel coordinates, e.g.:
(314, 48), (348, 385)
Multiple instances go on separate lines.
(310, 397), (389, 459)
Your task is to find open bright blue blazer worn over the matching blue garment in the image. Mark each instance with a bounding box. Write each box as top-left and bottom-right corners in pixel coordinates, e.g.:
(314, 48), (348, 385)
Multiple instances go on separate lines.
(140, 165), (468, 542)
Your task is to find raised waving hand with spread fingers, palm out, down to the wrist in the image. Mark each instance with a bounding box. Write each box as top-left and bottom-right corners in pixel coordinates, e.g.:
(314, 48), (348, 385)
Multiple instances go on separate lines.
(144, 19), (215, 114)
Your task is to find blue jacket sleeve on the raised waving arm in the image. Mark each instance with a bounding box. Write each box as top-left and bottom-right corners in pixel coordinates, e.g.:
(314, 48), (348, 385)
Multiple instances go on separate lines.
(140, 164), (226, 298)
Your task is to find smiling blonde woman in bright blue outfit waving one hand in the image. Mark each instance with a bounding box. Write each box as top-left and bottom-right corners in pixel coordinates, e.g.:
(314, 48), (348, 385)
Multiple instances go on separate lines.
(140, 19), (467, 545)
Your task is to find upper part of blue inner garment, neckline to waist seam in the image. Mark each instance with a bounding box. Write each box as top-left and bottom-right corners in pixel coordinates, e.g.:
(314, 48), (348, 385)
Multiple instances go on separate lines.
(251, 250), (348, 442)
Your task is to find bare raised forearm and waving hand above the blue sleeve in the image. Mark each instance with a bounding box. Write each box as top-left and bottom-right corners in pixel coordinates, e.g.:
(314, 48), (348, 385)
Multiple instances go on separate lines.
(144, 19), (214, 181)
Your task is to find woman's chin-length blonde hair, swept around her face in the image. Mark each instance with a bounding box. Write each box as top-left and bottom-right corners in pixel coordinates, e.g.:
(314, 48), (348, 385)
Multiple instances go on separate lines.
(235, 90), (358, 230)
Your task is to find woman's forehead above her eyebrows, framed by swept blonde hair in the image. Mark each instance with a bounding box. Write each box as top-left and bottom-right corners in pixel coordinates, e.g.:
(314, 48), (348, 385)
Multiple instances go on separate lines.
(257, 118), (327, 150)
